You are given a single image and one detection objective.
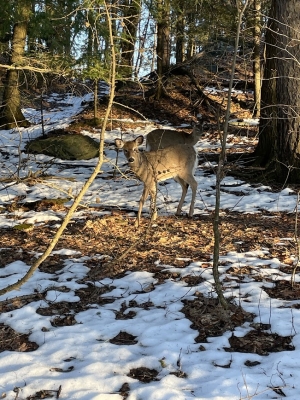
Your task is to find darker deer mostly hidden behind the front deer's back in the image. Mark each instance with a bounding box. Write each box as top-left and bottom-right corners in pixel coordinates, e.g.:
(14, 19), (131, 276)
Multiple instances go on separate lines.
(146, 122), (203, 151)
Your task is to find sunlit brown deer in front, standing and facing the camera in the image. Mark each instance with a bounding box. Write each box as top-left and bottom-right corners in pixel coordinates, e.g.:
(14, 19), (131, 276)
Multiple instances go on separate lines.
(115, 135), (197, 227)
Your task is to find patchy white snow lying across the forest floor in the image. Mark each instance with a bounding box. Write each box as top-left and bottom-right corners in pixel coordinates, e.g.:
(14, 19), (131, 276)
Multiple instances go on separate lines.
(0, 94), (300, 400)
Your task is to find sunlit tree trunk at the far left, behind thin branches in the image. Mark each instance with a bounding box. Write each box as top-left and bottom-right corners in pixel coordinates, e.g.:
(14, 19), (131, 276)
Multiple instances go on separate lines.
(0, 1), (31, 129)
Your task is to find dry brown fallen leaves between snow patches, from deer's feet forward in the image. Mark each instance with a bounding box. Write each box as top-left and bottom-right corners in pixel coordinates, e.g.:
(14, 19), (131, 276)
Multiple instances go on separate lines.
(0, 212), (300, 366)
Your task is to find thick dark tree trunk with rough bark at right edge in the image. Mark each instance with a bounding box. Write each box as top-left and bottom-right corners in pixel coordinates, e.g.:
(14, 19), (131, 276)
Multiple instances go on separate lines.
(255, 0), (300, 183)
